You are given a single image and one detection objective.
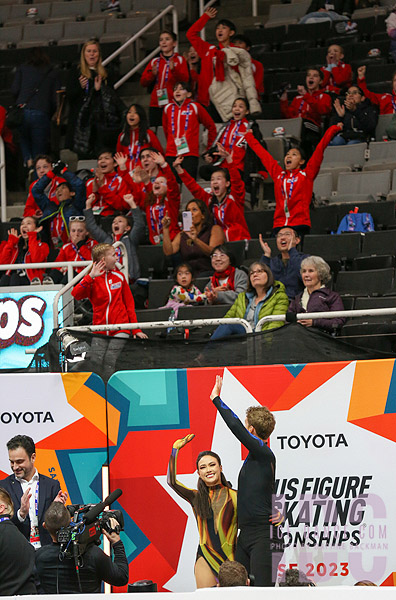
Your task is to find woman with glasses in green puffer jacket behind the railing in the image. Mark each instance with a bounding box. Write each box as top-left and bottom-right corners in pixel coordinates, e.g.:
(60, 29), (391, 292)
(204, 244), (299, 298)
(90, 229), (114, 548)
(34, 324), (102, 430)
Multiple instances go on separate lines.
(211, 262), (289, 340)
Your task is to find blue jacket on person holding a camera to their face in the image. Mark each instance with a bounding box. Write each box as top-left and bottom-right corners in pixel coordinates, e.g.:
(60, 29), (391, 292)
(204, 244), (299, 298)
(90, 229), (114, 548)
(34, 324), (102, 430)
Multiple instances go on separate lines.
(32, 171), (86, 235)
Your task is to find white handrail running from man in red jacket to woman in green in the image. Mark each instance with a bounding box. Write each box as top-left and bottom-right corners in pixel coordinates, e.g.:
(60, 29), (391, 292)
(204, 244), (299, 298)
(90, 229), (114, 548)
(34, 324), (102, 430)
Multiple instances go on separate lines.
(57, 317), (253, 337)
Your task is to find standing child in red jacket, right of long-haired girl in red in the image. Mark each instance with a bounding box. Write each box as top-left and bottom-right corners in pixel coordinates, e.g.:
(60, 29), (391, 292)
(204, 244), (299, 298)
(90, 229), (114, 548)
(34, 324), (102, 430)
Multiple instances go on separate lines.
(162, 81), (217, 177)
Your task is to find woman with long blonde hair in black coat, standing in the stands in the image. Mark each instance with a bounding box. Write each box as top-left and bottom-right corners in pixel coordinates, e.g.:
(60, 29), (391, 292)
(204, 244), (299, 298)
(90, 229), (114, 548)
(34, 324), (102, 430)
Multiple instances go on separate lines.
(65, 39), (126, 158)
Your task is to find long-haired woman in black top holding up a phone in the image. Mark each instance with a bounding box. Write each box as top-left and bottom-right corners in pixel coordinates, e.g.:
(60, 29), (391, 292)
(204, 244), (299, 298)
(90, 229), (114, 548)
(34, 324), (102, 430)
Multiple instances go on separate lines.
(162, 199), (225, 276)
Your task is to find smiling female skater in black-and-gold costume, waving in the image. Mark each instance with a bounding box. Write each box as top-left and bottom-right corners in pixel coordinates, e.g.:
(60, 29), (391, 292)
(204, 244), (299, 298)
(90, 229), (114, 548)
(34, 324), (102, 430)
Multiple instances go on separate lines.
(168, 433), (237, 588)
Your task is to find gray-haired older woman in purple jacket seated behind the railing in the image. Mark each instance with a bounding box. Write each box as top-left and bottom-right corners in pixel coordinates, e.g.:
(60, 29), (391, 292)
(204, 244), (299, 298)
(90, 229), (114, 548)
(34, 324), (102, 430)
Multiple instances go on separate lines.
(289, 256), (346, 333)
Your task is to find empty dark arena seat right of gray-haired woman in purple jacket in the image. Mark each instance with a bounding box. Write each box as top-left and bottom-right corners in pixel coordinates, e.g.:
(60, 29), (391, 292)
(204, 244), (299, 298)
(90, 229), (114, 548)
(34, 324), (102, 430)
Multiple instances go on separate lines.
(335, 268), (394, 296)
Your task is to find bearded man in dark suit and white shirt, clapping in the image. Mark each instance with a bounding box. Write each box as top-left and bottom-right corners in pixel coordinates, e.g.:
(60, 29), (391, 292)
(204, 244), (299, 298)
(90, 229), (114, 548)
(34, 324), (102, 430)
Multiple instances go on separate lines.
(0, 435), (67, 549)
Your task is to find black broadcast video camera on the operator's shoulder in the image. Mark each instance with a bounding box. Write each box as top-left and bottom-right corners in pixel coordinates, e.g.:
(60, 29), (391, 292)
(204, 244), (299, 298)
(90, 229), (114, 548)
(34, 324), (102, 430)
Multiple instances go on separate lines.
(57, 504), (124, 558)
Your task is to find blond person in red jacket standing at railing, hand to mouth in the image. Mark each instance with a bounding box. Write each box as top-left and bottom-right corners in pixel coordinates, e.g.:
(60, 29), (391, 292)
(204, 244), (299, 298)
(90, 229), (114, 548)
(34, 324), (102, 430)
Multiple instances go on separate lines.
(72, 244), (147, 338)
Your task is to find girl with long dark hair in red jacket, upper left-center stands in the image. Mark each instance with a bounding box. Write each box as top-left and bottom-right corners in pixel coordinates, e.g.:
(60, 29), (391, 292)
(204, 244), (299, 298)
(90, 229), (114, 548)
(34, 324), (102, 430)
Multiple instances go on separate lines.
(117, 104), (163, 175)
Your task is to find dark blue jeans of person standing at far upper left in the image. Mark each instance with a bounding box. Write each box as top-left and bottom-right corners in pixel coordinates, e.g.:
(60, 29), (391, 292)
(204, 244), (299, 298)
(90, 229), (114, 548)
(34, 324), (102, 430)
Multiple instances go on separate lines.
(20, 108), (51, 165)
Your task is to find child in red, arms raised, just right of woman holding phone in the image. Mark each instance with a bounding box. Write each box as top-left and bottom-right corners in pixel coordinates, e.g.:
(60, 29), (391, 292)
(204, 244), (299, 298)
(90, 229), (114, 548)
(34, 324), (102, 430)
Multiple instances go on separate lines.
(173, 144), (249, 242)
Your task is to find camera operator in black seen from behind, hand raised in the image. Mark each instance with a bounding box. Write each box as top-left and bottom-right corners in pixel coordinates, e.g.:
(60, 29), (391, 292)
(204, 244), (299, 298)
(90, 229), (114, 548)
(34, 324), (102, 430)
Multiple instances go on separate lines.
(36, 502), (128, 594)
